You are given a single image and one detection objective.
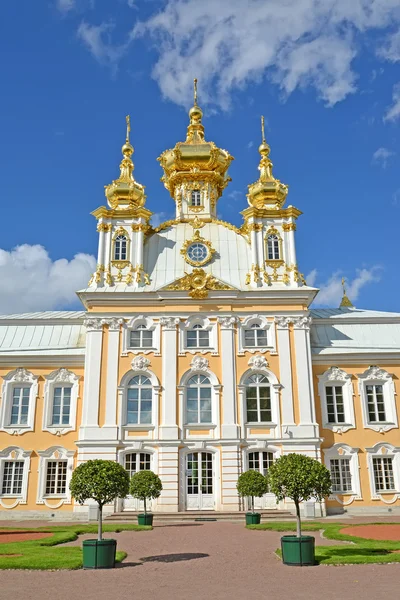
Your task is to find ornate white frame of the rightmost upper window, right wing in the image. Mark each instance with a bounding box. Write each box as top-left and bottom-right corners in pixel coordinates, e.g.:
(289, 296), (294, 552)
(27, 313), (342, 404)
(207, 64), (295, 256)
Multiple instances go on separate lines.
(358, 366), (398, 433)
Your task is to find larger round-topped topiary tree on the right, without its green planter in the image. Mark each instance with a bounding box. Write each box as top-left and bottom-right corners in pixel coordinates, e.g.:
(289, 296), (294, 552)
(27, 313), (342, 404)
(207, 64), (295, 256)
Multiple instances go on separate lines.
(268, 453), (332, 537)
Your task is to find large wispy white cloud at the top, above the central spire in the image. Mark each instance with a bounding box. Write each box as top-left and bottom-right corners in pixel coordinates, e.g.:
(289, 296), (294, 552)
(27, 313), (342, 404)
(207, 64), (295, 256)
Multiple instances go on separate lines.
(132, 0), (400, 109)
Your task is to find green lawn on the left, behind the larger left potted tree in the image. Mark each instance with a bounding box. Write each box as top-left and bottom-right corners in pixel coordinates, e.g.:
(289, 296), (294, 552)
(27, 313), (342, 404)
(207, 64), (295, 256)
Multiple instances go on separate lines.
(0, 523), (152, 569)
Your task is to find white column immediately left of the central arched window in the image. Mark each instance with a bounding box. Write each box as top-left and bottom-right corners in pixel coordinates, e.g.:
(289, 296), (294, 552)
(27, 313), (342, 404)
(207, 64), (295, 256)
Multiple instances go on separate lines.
(160, 317), (179, 440)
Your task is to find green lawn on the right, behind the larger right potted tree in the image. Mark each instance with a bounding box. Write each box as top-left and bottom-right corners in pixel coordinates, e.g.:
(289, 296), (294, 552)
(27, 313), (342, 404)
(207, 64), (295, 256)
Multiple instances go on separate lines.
(247, 521), (400, 565)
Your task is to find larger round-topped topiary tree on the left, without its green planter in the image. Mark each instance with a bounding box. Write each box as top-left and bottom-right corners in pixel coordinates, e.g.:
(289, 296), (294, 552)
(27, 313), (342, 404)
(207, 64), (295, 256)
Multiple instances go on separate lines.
(69, 459), (129, 540)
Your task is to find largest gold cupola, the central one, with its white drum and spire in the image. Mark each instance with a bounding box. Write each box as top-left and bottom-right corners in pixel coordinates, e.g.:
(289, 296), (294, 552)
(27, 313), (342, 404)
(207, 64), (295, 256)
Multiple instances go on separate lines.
(158, 79), (233, 218)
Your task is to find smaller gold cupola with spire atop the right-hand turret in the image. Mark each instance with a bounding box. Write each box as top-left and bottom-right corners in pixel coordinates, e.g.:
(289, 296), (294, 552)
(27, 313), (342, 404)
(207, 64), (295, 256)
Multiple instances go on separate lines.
(247, 117), (288, 209)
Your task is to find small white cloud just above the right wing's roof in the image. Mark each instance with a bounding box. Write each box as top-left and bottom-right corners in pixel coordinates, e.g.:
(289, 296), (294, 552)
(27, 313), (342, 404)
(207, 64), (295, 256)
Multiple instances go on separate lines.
(306, 266), (381, 308)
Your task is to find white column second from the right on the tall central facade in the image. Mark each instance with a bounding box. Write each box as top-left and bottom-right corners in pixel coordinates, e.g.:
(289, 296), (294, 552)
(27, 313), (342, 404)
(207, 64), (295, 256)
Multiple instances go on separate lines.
(275, 317), (295, 433)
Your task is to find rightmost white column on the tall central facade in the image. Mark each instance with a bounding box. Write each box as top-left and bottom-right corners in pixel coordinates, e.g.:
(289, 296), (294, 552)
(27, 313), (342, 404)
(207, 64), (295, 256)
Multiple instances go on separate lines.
(293, 317), (316, 425)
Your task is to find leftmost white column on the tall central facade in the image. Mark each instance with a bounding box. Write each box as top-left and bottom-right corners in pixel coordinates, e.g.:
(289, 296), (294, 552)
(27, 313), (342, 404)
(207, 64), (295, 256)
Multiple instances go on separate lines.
(80, 318), (103, 439)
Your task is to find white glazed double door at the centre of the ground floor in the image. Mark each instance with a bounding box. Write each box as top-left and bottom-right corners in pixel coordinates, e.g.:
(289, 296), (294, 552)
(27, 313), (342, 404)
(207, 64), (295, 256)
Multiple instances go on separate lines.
(185, 452), (215, 510)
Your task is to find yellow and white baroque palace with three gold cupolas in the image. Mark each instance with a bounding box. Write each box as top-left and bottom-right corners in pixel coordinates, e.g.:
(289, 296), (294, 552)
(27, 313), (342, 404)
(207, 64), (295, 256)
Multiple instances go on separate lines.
(0, 90), (400, 519)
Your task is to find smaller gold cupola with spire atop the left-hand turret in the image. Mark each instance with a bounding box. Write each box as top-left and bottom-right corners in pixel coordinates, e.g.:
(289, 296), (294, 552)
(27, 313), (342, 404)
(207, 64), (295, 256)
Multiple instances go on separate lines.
(105, 115), (146, 210)
